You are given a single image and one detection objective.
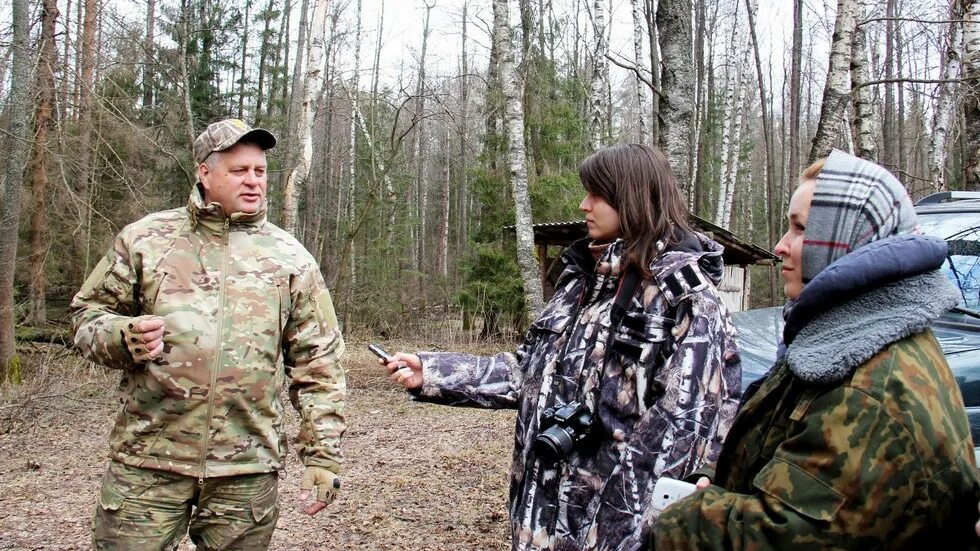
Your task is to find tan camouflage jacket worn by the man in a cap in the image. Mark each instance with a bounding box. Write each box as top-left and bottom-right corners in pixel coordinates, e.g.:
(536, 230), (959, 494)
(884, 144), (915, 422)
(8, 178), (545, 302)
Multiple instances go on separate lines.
(71, 189), (346, 478)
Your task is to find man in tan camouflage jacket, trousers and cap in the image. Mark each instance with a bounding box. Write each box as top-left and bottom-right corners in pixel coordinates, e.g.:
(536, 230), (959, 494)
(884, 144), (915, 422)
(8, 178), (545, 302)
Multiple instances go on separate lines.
(71, 119), (346, 549)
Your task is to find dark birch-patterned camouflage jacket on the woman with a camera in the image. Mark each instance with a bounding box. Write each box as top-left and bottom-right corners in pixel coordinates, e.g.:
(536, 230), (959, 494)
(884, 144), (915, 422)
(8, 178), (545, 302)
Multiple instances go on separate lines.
(417, 234), (741, 550)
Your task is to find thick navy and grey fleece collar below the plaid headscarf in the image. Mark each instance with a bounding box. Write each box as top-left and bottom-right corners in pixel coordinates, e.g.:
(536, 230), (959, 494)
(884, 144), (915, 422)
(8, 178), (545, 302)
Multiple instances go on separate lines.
(778, 235), (958, 384)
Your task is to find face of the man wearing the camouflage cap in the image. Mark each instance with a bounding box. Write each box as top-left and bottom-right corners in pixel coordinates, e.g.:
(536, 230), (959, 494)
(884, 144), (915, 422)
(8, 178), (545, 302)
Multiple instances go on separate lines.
(197, 143), (266, 216)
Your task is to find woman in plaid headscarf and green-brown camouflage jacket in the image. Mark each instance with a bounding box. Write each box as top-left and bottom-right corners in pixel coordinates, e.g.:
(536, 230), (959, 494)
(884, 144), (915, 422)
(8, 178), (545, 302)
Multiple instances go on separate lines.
(651, 151), (980, 551)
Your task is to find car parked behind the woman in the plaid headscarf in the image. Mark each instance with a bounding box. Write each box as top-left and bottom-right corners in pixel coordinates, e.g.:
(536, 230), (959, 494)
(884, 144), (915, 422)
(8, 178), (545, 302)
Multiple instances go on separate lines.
(732, 192), (980, 459)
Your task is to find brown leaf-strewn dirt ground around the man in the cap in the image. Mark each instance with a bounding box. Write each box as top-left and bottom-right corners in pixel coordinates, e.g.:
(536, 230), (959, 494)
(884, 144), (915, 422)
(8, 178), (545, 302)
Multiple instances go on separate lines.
(0, 342), (514, 551)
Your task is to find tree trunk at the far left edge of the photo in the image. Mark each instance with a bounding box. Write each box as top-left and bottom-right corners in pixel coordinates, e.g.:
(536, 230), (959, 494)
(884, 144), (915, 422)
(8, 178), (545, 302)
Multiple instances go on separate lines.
(0, 0), (31, 383)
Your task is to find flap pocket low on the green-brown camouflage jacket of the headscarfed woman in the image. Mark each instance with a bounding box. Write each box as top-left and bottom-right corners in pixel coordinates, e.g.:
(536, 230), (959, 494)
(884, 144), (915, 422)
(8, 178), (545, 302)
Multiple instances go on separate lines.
(752, 458), (844, 522)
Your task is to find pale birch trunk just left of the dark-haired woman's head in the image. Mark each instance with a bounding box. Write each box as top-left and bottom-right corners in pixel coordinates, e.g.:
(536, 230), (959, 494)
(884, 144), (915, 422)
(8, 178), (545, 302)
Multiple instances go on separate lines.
(493, 0), (544, 319)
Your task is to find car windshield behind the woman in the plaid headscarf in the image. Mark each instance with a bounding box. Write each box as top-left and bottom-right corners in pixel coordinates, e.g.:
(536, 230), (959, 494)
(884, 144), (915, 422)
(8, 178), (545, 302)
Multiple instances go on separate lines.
(918, 212), (980, 312)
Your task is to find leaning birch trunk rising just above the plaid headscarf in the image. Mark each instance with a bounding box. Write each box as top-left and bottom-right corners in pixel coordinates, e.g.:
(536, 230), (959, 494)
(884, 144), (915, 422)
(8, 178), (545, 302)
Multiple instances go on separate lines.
(809, 0), (857, 163)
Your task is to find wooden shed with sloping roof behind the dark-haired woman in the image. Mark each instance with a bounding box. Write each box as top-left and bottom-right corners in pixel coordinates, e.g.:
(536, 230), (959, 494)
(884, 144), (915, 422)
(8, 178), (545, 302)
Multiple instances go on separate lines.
(508, 216), (778, 312)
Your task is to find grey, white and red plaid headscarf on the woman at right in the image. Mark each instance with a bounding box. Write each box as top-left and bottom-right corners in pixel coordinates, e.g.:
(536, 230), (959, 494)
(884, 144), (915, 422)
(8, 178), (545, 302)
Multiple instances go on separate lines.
(803, 149), (915, 283)
